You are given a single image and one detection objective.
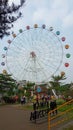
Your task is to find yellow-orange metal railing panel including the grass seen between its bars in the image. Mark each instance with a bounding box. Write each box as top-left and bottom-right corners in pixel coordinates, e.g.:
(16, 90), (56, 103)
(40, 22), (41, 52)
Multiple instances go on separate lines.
(48, 99), (73, 130)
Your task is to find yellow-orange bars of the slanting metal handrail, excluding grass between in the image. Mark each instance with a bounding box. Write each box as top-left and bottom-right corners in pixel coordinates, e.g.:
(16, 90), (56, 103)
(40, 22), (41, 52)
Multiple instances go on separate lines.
(48, 99), (73, 130)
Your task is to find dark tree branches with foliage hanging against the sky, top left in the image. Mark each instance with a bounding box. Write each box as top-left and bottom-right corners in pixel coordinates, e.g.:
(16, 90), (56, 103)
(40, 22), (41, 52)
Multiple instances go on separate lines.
(0, 0), (25, 38)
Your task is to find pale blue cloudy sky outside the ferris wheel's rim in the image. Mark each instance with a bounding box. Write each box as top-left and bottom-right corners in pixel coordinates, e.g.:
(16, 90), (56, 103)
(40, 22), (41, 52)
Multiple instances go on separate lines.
(0, 0), (73, 82)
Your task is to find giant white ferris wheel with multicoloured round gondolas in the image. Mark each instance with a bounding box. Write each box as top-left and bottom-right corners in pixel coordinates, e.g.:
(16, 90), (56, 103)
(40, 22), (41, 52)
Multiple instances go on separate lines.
(1, 24), (70, 83)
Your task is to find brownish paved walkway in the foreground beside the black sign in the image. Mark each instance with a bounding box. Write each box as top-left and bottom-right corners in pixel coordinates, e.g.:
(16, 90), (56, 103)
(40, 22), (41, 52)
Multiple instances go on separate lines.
(0, 105), (73, 130)
